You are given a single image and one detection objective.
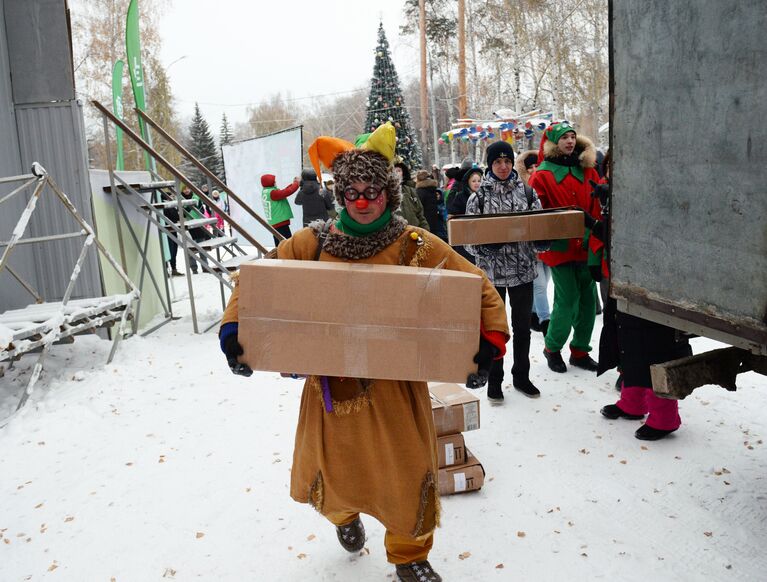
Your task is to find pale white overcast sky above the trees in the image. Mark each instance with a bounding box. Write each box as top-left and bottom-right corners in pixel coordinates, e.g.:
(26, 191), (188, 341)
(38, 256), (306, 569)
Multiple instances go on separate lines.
(160, 0), (419, 134)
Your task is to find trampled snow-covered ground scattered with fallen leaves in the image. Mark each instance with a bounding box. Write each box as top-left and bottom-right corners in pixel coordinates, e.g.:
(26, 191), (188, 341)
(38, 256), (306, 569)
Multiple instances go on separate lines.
(0, 275), (767, 582)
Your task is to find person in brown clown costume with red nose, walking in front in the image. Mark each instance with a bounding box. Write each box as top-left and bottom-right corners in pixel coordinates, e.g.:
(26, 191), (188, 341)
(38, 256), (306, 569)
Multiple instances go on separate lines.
(219, 124), (509, 582)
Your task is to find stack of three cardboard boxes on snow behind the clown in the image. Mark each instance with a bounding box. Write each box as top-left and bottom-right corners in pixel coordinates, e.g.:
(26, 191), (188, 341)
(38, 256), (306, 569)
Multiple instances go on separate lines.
(429, 384), (485, 495)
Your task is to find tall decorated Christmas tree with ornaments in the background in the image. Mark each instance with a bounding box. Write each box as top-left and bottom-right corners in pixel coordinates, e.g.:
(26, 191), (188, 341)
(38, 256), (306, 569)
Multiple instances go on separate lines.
(365, 24), (423, 172)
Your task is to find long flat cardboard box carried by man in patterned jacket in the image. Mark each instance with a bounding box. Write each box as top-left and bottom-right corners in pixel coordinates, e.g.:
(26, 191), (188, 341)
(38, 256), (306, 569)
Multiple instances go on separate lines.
(447, 208), (585, 245)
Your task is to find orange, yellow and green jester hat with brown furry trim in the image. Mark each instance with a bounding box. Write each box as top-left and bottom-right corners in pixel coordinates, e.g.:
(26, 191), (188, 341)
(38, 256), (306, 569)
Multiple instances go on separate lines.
(308, 122), (402, 210)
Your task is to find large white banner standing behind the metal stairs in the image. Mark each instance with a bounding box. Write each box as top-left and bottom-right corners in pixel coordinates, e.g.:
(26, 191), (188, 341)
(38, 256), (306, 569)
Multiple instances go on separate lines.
(222, 126), (303, 247)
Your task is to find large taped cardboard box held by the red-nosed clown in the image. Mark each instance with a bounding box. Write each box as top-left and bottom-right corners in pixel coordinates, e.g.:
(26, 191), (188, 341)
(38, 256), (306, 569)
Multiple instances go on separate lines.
(239, 260), (482, 382)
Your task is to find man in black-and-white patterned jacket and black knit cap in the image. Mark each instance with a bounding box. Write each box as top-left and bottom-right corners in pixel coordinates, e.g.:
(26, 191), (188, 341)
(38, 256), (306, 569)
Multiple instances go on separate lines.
(466, 141), (546, 404)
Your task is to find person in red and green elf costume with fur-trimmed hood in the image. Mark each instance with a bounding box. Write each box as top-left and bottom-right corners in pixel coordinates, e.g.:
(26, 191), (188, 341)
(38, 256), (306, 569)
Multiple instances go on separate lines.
(530, 122), (600, 373)
